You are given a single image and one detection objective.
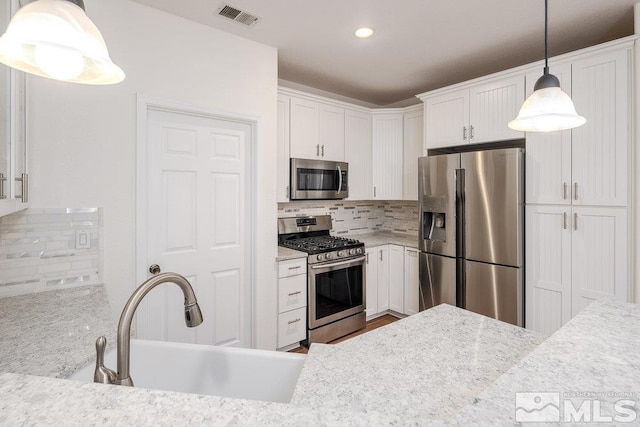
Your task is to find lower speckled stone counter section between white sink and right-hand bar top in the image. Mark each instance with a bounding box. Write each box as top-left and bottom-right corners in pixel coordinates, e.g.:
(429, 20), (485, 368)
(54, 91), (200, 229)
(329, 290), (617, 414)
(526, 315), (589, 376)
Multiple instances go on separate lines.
(291, 304), (544, 422)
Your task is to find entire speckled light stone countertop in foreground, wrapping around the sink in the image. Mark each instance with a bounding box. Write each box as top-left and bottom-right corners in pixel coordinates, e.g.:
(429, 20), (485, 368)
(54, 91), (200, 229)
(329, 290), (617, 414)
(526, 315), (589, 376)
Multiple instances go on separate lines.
(0, 302), (640, 425)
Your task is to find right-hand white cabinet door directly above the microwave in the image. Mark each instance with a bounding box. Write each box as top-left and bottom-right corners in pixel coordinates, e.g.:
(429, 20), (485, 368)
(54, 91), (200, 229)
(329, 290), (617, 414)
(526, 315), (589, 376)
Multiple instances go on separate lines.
(318, 103), (344, 162)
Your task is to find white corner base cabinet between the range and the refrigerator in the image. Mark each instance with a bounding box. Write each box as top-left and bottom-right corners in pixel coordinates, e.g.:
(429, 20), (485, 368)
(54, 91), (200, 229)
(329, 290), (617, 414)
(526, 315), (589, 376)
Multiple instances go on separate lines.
(366, 245), (419, 319)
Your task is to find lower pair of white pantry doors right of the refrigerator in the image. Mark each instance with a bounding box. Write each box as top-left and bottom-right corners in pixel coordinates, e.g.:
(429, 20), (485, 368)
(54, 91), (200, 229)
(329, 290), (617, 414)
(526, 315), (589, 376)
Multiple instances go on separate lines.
(525, 205), (629, 335)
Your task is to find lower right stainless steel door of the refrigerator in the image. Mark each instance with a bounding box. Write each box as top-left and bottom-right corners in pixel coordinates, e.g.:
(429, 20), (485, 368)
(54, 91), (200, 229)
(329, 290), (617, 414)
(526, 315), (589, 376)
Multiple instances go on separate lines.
(464, 261), (524, 326)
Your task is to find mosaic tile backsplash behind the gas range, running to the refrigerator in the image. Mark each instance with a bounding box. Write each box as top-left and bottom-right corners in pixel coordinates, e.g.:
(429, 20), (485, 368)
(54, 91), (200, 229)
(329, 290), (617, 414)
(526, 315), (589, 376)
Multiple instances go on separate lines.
(278, 200), (418, 236)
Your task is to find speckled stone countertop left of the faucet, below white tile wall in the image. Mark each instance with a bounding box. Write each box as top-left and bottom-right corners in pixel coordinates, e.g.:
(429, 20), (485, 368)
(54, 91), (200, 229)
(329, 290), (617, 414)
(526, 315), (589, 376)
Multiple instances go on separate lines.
(0, 284), (117, 378)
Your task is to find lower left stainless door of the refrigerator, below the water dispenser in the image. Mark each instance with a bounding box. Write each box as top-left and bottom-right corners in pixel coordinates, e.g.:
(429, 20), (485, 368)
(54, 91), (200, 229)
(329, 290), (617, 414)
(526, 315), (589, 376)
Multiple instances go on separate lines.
(419, 252), (457, 311)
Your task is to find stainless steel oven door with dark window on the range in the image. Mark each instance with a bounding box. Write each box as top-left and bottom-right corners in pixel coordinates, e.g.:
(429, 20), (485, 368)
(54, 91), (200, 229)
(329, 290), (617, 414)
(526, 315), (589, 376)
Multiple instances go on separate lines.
(309, 257), (366, 329)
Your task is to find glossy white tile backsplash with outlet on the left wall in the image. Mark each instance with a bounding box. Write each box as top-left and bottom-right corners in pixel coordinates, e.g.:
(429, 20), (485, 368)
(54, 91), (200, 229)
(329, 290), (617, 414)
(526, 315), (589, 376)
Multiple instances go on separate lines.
(0, 208), (104, 297)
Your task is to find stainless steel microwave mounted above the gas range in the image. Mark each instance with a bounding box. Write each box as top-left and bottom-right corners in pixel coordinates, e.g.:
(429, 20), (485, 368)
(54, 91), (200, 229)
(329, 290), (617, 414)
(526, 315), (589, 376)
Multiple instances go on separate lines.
(290, 159), (349, 200)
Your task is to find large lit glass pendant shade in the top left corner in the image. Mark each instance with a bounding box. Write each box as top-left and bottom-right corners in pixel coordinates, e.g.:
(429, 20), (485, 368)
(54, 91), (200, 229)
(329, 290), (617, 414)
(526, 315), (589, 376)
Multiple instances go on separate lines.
(0, 0), (124, 85)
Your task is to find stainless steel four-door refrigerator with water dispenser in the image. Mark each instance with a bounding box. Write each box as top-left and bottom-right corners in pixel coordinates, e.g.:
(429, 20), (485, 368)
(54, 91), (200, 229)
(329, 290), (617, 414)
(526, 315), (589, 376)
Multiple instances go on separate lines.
(418, 148), (524, 326)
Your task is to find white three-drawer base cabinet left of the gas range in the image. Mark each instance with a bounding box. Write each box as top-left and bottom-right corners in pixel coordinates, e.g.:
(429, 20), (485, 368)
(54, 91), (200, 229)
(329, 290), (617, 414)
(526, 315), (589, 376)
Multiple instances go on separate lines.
(278, 258), (307, 348)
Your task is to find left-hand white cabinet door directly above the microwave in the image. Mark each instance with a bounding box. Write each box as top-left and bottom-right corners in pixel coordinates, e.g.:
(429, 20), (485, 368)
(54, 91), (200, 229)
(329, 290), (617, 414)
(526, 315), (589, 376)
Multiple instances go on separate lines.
(289, 96), (321, 159)
